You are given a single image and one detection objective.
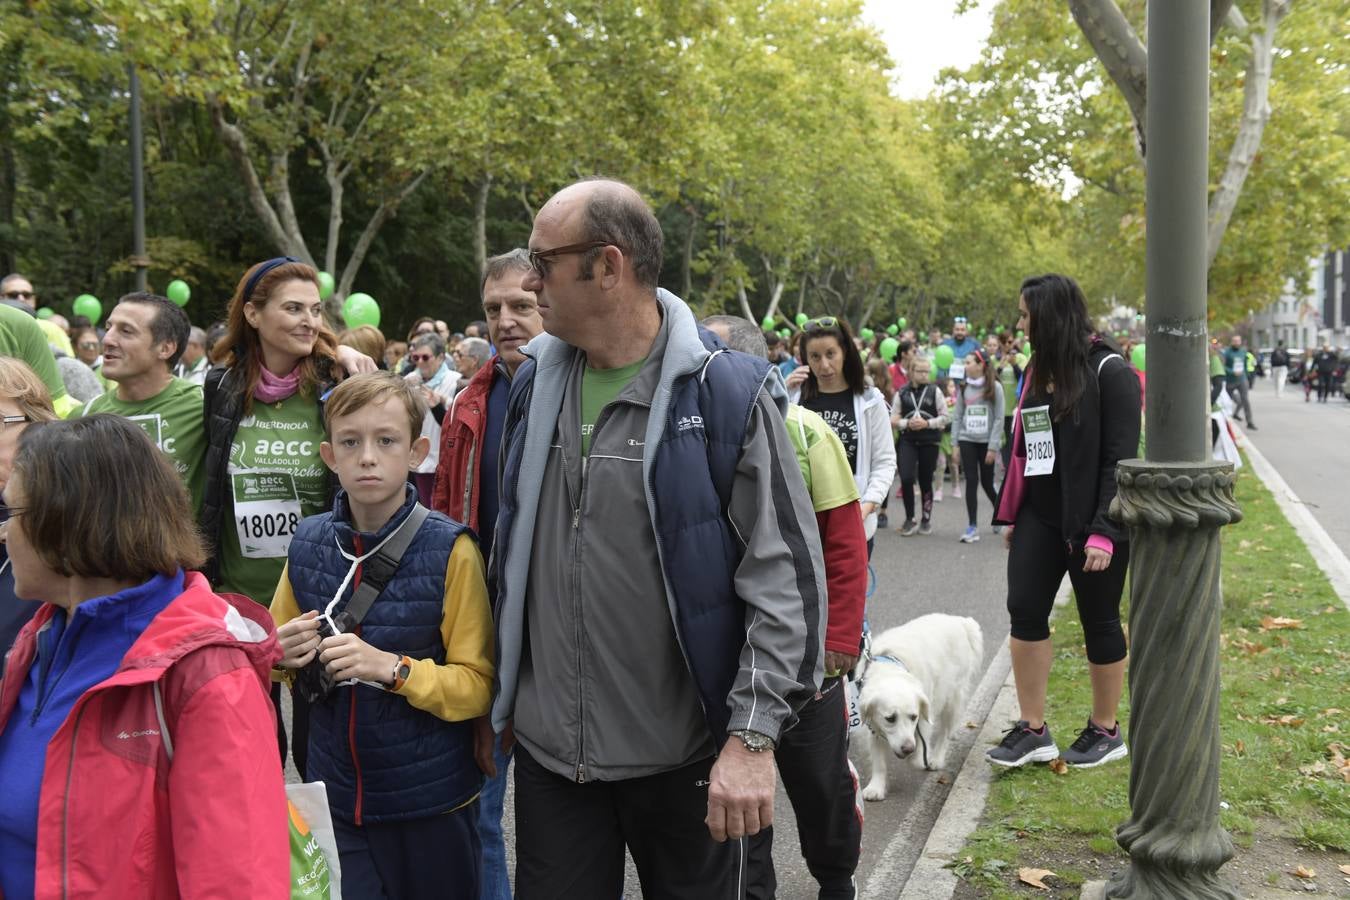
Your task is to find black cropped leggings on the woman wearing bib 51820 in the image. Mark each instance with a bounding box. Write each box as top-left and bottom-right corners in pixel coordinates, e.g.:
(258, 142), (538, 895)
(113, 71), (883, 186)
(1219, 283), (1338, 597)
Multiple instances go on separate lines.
(1008, 510), (1130, 665)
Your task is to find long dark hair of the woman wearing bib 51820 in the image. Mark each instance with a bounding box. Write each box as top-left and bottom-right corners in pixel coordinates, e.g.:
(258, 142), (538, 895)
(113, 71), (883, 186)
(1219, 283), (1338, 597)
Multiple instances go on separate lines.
(1022, 274), (1092, 420)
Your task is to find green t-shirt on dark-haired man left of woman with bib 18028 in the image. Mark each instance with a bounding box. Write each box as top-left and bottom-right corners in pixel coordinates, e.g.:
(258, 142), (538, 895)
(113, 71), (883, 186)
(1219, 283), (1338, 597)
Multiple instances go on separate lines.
(70, 378), (207, 515)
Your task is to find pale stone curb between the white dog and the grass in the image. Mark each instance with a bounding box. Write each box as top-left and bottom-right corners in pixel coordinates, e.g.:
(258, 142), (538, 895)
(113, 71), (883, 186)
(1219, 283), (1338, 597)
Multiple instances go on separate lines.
(891, 578), (1071, 900)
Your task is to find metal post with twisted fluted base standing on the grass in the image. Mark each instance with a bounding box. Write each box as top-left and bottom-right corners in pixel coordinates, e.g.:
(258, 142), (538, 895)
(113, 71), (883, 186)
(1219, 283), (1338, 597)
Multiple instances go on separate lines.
(1106, 0), (1242, 900)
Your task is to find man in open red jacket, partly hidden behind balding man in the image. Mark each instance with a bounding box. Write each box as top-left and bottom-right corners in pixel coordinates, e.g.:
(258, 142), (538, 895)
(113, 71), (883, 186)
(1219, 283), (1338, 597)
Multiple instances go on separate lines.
(431, 250), (544, 900)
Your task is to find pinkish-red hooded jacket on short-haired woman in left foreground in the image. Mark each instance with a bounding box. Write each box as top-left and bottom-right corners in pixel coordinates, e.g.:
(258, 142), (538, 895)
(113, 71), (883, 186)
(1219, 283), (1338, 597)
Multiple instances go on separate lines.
(0, 572), (290, 900)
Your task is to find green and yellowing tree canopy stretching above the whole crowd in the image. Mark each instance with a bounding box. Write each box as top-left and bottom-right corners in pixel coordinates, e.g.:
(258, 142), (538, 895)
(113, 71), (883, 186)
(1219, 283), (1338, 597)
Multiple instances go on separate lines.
(0, 0), (1350, 335)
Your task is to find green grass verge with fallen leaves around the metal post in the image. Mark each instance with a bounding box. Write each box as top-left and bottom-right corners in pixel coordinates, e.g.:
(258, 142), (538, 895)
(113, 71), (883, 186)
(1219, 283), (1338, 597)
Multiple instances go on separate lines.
(953, 467), (1350, 897)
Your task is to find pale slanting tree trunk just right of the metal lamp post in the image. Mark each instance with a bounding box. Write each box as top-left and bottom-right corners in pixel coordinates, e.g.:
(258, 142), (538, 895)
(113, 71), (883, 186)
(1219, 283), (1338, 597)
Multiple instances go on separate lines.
(1206, 0), (1289, 266)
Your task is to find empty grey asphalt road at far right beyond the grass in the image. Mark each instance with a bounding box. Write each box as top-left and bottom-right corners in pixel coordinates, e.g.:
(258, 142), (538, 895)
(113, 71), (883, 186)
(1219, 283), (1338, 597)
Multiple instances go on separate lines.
(1249, 378), (1350, 551)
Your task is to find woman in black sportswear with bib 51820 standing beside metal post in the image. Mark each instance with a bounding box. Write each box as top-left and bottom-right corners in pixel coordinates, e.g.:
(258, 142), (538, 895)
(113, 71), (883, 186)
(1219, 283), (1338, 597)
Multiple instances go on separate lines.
(988, 275), (1139, 766)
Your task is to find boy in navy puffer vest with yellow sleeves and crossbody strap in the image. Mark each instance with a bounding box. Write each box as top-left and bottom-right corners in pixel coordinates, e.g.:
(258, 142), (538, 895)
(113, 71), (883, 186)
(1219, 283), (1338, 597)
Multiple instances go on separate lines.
(271, 372), (493, 900)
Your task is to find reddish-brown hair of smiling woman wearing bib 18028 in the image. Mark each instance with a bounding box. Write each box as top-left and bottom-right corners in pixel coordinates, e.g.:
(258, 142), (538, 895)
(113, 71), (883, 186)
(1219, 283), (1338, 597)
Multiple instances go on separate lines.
(211, 259), (338, 412)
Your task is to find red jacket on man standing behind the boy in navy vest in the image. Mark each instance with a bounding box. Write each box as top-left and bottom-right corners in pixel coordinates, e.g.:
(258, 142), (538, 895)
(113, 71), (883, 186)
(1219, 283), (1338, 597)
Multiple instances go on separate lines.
(431, 356), (498, 534)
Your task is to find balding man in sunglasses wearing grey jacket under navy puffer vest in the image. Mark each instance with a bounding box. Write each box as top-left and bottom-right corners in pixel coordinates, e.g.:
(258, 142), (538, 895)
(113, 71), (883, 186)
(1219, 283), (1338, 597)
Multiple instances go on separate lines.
(493, 181), (826, 900)
